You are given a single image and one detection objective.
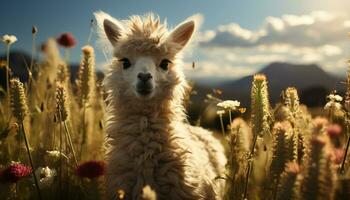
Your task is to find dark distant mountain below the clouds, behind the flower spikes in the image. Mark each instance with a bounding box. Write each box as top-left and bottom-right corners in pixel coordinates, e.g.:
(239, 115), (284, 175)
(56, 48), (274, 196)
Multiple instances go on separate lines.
(191, 62), (345, 106)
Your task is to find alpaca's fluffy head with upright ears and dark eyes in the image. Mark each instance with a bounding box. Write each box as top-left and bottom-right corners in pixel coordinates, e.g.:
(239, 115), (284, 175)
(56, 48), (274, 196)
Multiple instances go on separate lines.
(95, 12), (195, 108)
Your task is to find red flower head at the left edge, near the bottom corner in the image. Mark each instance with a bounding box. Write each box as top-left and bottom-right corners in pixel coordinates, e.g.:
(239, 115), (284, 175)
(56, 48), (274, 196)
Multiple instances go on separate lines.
(0, 163), (32, 183)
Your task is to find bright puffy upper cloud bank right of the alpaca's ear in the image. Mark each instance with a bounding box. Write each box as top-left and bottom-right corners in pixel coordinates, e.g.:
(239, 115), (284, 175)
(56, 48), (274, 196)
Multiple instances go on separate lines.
(201, 11), (350, 47)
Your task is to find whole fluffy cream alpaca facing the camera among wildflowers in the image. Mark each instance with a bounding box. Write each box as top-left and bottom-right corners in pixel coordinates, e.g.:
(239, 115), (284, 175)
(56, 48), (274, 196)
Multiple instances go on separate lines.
(95, 12), (226, 200)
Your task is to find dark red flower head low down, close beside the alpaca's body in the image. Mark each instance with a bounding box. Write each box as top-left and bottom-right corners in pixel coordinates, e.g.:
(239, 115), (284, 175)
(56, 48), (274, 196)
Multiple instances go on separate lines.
(76, 161), (106, 179)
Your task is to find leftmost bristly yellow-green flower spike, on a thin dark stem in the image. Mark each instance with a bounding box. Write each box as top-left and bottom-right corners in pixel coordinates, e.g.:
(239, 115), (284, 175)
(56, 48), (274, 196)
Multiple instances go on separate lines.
(10, 79), (28, 121)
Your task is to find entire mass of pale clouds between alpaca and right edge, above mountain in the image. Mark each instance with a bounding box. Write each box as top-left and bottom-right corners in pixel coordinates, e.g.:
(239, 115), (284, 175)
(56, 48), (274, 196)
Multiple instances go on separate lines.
(186, 11), (350, 78)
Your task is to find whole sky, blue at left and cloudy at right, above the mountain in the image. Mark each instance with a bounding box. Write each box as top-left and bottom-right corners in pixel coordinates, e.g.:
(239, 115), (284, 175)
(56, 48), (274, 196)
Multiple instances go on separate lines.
(0, 0), (350, 78)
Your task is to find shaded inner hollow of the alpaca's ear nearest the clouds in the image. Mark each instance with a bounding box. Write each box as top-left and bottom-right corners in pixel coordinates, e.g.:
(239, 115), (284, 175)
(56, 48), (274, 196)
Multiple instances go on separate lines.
(167, 20), (195, 48)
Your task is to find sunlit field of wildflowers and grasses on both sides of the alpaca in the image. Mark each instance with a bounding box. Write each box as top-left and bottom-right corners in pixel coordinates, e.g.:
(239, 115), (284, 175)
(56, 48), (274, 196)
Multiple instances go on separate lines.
(0, 27), (350, 200)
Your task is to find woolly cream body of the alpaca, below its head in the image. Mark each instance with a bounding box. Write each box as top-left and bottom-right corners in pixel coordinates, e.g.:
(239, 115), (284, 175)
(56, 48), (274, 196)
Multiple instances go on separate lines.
(107, 103), (225, 199)
